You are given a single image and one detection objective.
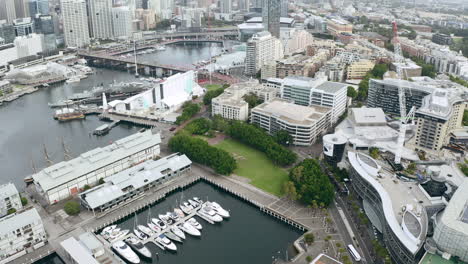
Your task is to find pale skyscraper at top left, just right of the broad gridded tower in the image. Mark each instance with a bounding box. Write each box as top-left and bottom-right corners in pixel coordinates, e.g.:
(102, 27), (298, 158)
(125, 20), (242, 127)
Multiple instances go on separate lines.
(89, 0), (114, 39)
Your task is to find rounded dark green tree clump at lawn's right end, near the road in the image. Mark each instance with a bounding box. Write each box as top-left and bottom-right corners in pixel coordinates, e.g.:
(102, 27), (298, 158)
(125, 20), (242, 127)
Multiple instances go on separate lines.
(289, 159), (335, 206)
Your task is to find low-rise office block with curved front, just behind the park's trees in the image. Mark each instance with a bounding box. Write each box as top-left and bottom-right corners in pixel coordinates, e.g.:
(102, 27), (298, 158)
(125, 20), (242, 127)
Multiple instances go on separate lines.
(251, 98), (332, 146)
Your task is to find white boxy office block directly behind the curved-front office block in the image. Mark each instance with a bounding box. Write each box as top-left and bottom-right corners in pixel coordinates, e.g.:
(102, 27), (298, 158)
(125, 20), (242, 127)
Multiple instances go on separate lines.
(267, 76), (347, 124)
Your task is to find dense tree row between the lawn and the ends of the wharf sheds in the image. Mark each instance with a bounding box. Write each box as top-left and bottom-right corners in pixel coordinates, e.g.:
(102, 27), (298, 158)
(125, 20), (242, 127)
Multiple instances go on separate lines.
(169, 133), (237, 175)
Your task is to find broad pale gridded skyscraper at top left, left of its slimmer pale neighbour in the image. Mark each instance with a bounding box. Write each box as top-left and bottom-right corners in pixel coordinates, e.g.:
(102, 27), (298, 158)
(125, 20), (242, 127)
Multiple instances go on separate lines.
(60, 0), (89, 48)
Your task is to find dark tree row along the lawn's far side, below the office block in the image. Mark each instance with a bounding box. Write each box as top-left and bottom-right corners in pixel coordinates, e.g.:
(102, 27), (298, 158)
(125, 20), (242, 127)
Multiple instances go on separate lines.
(227, 121), (297, 166)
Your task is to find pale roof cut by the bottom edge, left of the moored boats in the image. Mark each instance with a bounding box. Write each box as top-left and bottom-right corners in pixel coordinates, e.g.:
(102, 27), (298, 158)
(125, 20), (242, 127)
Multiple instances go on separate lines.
(60, 237), (100, 264)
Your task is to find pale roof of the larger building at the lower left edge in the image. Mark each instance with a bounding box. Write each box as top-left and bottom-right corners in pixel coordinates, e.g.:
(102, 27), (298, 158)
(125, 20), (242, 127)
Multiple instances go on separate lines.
(0, 208), (42, 238)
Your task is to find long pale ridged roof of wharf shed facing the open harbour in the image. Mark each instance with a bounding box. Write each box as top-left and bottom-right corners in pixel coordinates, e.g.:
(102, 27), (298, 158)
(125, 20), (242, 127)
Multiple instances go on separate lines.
(32, 130), (161, 192)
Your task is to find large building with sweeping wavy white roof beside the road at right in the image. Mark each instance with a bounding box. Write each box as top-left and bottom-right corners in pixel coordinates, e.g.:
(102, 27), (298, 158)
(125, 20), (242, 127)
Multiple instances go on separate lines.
(348, 151), (432, 264)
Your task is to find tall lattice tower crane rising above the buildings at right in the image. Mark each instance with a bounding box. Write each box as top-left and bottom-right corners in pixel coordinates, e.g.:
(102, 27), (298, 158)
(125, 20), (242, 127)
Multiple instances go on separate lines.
(392, 21), (415, 164)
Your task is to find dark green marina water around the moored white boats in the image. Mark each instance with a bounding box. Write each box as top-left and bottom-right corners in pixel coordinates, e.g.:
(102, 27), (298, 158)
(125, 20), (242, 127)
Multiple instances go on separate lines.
(117, 182), (302, 264)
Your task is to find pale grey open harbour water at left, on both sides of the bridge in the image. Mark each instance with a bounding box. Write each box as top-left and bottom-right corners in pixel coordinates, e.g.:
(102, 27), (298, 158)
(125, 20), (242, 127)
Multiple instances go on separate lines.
(0, 44), (221, 189)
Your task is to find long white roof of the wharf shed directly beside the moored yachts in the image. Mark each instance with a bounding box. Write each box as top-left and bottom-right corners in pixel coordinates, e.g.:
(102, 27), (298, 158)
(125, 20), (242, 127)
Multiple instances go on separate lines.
(80, 154), (192, 209)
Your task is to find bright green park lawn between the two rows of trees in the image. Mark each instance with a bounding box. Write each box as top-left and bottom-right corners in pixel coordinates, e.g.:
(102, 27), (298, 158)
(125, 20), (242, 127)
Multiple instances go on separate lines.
(215, 139), (288, 196)
